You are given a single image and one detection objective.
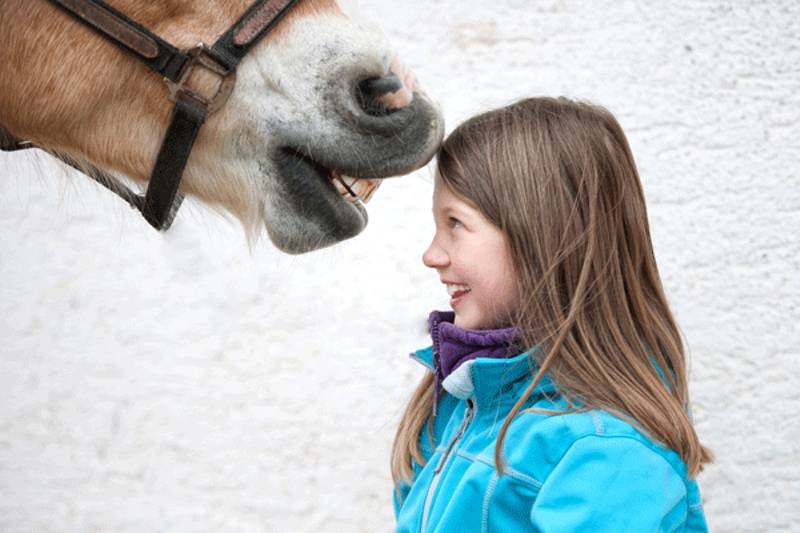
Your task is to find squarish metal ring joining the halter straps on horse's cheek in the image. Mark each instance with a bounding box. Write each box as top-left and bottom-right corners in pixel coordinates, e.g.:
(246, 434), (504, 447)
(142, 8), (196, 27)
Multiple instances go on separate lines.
(165, 43), (236, 115)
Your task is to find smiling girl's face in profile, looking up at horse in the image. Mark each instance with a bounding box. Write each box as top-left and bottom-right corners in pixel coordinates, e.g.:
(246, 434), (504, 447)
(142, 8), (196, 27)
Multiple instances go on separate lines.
(422, 175), (518, 329)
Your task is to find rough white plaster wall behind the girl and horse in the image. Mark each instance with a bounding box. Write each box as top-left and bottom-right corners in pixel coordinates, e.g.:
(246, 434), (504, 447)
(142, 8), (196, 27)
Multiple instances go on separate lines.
(0, 0), (800, 532)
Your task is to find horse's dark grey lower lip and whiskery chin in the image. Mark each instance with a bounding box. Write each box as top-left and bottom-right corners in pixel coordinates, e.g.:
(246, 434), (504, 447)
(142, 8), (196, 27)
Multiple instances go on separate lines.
(264, 148), (369, 254)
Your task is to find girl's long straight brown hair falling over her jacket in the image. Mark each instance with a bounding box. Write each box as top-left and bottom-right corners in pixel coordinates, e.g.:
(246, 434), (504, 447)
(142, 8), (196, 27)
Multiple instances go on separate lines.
(392, 98), (712, 484)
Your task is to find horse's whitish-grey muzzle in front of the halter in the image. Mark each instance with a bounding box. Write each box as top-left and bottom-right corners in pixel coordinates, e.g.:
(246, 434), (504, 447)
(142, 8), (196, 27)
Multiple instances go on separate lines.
(179, 6), (443, 253)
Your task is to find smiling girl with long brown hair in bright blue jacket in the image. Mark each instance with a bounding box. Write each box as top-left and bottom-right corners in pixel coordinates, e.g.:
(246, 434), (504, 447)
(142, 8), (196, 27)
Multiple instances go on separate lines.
(392, 98), (711, 533)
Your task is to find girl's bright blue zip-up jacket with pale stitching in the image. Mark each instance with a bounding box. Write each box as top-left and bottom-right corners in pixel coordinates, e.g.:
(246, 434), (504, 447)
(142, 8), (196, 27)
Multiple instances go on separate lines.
(395, 348), (708, 533)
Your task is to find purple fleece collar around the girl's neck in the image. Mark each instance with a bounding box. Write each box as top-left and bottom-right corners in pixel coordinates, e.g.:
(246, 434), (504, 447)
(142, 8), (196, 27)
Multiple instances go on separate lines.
(428, 311), (517, 413)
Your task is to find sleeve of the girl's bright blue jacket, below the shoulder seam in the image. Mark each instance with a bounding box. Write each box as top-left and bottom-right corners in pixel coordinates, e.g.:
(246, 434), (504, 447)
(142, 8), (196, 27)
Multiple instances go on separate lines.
(530, 435), (688, 533)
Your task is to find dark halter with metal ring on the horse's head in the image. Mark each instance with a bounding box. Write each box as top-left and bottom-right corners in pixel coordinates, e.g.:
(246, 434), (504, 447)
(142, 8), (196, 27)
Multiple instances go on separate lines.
(0, 0), (298, 230)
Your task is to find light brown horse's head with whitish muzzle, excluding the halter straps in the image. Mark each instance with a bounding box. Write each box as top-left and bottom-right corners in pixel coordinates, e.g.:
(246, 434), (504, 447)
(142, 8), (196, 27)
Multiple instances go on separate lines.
(0, 0), (443, 253)
